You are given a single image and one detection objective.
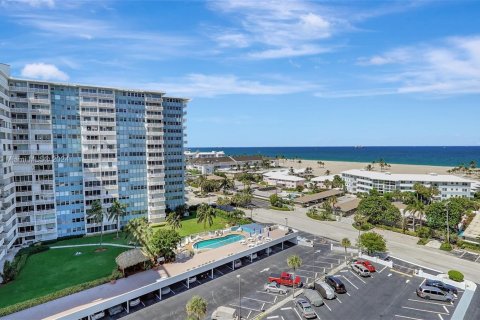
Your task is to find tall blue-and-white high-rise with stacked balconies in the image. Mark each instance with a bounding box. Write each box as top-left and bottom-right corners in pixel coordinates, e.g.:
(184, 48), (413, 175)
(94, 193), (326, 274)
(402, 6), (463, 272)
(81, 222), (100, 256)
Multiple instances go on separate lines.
(0, 64), (188, 259)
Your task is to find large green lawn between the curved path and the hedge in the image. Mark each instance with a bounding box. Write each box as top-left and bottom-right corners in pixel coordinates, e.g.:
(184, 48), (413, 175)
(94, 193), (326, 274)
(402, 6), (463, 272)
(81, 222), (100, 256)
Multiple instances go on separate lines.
(0, 247), (126, 307)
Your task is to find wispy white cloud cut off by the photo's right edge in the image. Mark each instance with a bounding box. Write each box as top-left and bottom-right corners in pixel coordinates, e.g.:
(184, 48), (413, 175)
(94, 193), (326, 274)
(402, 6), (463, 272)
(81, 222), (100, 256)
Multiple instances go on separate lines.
(359, 36), (480, 94)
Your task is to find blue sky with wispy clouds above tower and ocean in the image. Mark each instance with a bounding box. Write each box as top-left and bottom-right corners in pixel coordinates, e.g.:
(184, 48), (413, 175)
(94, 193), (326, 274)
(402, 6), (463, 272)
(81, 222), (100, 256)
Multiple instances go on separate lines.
(0, 0), (480, 147)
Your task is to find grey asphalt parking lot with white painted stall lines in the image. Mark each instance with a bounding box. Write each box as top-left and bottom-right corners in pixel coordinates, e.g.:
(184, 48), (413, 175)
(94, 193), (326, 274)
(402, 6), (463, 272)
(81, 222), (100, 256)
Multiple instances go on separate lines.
(116, 233), (478, 320)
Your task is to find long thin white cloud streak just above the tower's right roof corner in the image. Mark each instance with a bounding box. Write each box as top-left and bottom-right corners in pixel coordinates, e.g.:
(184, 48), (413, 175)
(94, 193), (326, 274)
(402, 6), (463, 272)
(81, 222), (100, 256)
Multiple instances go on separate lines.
(144, 73), (317, 97)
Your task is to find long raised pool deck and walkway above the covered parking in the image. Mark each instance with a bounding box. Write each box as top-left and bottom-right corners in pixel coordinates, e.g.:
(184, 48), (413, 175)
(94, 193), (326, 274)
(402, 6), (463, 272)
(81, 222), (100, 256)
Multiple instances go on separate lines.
(7, 229), (285, 320)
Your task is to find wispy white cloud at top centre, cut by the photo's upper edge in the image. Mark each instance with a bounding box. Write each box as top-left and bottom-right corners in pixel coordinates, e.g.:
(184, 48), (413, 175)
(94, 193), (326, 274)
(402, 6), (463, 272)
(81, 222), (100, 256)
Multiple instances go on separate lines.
(211, 0), (340, 59)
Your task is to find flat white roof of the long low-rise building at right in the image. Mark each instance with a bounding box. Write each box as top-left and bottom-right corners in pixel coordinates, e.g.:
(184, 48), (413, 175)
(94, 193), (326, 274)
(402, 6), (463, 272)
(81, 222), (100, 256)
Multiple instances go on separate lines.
(342, 169), (474, 183)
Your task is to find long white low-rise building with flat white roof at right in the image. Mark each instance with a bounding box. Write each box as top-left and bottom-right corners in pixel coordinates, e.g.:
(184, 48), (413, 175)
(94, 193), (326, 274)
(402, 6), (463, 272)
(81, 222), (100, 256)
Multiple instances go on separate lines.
(342, 169), (475, 199)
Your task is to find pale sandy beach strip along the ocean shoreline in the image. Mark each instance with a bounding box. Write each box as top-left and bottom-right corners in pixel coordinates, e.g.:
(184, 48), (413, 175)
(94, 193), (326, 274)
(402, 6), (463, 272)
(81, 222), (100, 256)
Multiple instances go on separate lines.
(279, 160), (452, 176)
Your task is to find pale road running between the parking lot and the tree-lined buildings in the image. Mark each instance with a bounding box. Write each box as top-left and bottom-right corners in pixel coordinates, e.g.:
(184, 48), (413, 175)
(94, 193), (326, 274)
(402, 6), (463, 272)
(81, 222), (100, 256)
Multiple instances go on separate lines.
(253, 207), (480, 283)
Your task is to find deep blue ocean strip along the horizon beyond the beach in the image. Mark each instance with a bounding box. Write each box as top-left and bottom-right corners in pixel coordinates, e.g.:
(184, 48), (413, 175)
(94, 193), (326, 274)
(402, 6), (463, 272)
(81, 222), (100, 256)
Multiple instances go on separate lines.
(188, 146), (480, 167)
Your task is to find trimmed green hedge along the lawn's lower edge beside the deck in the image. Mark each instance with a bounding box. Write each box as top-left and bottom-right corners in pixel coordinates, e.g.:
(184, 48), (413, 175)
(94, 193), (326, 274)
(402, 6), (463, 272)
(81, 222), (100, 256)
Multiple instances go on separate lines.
(0, 270), (122, 317)
